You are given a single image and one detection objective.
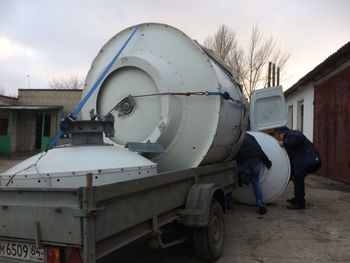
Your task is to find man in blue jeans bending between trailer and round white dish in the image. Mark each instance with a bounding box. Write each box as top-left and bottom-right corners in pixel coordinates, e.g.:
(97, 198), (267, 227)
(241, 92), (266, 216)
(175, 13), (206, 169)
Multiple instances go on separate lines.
(236, 133), (272, 215)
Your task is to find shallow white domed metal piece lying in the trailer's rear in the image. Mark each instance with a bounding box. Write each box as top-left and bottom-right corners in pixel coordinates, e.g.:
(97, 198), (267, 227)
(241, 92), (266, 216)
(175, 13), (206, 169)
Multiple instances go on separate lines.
(0, 145), (157, 188)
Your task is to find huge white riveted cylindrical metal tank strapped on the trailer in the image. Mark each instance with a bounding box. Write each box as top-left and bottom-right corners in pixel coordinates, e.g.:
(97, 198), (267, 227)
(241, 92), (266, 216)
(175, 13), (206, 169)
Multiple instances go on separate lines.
(82, 23), (247, 171)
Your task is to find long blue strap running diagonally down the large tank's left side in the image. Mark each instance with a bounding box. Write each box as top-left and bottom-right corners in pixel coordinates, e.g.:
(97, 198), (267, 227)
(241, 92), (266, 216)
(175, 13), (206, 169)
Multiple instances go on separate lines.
(46, 26), (139, 151)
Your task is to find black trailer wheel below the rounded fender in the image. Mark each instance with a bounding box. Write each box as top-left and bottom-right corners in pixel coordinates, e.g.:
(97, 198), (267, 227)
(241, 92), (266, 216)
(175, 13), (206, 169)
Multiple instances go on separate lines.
(193, 199), (225, 262)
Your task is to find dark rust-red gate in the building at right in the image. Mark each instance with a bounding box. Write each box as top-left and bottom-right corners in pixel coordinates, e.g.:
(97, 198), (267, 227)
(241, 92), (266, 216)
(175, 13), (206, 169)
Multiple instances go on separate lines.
(314, 65), (350, 183)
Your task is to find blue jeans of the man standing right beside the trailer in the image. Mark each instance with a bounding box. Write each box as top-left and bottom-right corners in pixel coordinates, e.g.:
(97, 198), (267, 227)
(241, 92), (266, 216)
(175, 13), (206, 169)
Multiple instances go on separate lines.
(237, 159), (265, 207)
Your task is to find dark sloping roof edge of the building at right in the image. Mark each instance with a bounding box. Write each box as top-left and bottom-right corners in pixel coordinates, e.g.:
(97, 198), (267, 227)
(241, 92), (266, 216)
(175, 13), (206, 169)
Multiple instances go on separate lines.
(284, 42), (350, 97)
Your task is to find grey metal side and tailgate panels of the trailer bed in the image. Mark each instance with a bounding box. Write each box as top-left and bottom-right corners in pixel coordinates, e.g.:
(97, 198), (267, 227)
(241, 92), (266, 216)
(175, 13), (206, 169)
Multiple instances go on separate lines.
(0, 162), (235, 262)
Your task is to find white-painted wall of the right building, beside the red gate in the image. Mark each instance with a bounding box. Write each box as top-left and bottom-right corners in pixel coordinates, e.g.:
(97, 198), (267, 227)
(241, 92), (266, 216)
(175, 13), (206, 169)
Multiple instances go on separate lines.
(285, 84), (314, 141)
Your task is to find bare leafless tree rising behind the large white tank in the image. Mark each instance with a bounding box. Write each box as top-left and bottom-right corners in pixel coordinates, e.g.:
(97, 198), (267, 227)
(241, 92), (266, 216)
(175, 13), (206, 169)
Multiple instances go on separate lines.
(204, 25), (290, 99)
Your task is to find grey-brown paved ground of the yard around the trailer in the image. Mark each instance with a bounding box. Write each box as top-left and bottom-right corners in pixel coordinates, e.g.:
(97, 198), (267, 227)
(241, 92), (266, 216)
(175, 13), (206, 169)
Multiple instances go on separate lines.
(0, 156), (350, 263)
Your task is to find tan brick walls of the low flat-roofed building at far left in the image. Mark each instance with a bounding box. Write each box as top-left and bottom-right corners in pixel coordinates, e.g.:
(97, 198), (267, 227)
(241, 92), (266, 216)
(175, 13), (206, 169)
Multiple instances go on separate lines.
(0, 89), (82, 153)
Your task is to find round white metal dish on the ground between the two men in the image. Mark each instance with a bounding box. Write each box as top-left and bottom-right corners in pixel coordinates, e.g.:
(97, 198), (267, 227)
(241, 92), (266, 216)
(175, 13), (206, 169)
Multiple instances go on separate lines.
(232, 132), (290, 205)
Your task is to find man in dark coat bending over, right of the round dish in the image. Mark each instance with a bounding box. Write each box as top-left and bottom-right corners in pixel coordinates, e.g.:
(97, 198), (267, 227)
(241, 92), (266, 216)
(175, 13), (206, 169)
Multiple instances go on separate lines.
(275, 127), (321, 209)
